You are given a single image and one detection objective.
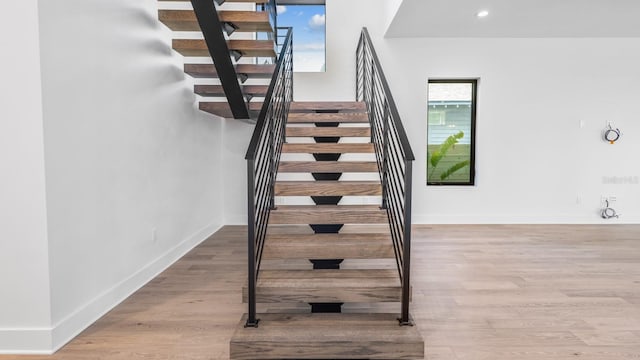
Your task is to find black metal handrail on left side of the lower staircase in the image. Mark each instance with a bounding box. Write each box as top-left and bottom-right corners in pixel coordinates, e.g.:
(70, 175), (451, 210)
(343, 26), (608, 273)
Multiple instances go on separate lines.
(245, 28), (293, 327)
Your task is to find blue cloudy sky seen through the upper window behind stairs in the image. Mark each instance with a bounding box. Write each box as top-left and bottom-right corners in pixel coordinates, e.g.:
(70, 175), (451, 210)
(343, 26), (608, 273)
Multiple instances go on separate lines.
(278, 5), (325, 72)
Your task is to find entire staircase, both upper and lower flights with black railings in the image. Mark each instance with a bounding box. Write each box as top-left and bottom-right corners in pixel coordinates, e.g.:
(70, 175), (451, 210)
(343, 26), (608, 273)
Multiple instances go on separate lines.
(158, 0), (424, 359)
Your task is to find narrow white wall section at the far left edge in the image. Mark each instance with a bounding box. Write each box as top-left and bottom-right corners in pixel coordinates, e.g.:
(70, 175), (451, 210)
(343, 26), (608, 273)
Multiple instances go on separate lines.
(0, 0), (51, 353)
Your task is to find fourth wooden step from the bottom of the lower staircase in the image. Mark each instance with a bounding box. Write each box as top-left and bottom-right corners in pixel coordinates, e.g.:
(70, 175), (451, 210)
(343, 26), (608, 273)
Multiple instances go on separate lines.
(269, 205), (388, 224)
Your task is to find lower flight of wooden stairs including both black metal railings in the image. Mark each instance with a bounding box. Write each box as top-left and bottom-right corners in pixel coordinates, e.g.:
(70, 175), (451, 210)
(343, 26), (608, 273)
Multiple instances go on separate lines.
(230, 29), (424, 359)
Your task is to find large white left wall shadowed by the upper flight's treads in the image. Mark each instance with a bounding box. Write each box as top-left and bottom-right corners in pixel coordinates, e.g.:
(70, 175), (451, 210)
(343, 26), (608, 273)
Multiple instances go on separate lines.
(39, 0), (224, 347)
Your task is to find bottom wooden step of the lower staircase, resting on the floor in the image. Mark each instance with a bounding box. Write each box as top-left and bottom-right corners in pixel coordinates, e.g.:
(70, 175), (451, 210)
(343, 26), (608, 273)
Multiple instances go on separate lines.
(229, 313), (424, 360)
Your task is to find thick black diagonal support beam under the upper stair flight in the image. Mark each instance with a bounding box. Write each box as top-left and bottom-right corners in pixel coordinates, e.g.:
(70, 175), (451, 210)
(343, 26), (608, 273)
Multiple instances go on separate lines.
(191, 0), (250, 119)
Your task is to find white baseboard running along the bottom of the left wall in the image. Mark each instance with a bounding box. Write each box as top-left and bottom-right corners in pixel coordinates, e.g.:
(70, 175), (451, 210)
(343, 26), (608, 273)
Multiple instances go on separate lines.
(0, 219), (223, 355)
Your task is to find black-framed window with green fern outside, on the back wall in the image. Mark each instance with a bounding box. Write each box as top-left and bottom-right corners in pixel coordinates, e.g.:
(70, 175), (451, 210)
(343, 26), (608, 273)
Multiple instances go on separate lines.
(427, 79), (478, 185)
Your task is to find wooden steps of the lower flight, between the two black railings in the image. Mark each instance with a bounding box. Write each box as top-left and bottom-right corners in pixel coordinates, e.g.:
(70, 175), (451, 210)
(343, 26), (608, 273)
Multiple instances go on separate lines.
(230, 102), (424, 359)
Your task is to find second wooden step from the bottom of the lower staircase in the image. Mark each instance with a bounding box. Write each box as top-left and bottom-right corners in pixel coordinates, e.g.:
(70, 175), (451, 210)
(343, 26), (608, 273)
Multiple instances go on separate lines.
(242, 269), (402, 303)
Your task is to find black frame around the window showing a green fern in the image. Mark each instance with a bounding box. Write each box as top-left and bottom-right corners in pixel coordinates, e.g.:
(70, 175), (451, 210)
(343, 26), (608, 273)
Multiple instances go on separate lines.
(425, 78), (479, 186)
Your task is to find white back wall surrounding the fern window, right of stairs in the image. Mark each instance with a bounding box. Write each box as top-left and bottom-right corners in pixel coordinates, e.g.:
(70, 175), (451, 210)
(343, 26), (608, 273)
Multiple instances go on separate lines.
(294, 0), (640, 223)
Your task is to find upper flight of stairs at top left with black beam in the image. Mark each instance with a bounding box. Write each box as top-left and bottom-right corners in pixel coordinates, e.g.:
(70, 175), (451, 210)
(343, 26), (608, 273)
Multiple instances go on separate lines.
(158, 0), (277, 119)
